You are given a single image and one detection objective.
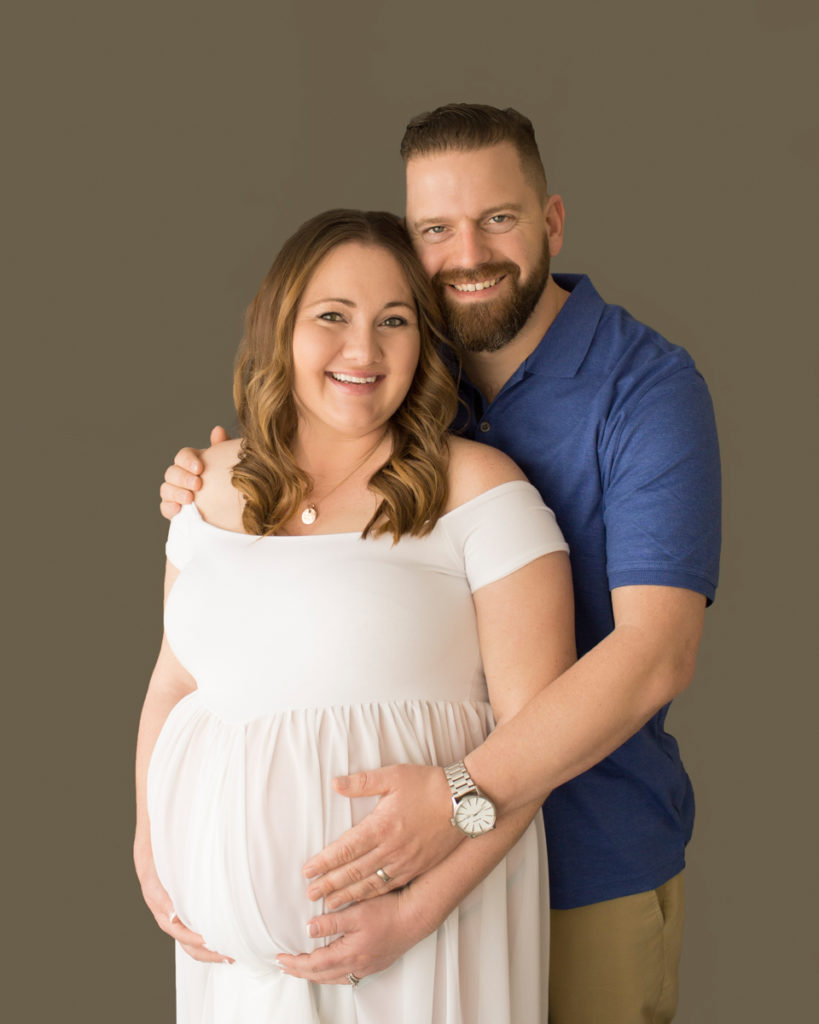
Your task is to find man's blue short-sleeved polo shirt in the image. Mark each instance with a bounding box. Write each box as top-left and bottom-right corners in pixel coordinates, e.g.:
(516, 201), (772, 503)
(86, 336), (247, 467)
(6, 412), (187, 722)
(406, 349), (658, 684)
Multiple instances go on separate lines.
(460, 274), (720, 909)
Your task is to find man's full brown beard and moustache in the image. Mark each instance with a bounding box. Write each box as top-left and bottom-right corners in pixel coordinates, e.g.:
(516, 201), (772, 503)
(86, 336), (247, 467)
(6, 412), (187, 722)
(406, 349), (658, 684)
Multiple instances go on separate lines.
(432, 239), (550, 352)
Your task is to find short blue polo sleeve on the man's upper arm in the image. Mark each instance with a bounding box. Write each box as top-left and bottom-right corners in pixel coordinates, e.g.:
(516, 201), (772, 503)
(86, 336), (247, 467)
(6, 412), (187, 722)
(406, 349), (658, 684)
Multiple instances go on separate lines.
(600, 364), (721, 603)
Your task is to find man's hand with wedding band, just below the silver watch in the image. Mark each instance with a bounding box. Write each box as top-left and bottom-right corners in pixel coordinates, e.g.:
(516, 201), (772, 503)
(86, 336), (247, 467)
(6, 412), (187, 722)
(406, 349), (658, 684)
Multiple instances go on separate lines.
(304, 765), (464, 910)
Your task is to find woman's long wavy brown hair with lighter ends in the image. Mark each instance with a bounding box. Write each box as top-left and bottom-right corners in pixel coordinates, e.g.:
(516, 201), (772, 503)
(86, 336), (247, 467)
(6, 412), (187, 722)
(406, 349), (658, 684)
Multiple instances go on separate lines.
(231, 210), (458, 541)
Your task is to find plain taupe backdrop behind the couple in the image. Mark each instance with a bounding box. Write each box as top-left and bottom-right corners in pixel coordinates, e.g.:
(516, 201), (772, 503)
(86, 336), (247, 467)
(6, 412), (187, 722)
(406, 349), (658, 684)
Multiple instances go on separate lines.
(0, 0), (819, 1024)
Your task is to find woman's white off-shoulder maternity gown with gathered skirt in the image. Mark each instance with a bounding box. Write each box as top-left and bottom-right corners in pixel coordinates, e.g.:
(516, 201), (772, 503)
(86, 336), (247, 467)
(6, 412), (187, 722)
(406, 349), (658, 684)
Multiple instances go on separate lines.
(147, 481), (567, 1024)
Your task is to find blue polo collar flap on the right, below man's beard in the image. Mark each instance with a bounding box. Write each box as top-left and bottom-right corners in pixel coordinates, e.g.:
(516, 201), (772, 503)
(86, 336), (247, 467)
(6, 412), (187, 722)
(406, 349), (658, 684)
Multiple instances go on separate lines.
(522, 273), (606, 378)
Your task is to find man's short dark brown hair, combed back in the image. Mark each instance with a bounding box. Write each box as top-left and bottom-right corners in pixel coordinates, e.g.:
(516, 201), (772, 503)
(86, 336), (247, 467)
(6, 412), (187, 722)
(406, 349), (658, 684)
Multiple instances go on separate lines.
(401, 103), (547, 197)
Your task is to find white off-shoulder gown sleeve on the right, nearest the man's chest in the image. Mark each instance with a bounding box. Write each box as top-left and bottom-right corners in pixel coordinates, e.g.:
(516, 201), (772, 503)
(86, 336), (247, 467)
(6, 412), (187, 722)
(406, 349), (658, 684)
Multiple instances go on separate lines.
(447, 480), (569, 594)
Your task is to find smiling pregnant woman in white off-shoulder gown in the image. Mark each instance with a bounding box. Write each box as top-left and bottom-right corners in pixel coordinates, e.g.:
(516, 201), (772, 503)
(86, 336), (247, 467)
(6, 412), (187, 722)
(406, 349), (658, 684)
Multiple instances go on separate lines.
(134, 211), (573, 1024)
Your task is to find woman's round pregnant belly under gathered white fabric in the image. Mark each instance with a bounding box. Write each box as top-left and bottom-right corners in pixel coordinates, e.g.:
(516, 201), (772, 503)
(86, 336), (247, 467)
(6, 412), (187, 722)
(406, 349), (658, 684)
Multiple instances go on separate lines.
(148, 692), (490, 971)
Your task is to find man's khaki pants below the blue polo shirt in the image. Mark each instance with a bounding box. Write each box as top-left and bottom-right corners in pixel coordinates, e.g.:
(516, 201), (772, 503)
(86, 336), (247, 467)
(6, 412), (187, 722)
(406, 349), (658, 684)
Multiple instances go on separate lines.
(549, 872), (685, 1024)
